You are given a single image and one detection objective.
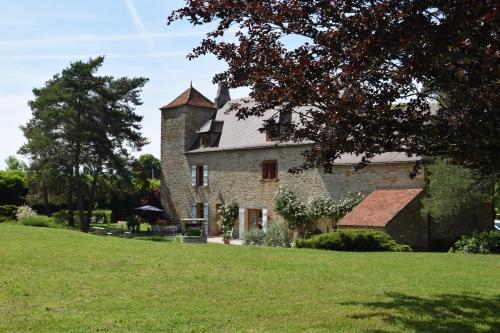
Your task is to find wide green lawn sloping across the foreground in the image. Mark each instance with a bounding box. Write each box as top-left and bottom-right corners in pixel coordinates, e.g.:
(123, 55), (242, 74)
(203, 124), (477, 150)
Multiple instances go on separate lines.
(0, 224), (500, 333)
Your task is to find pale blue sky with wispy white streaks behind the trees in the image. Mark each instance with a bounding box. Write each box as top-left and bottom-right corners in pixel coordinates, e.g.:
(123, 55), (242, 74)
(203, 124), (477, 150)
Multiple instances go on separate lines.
(0, 0), (248, 169)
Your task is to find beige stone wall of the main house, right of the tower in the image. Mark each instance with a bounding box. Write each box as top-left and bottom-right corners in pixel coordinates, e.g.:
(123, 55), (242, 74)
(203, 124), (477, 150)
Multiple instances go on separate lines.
(180, 146), (423, 235)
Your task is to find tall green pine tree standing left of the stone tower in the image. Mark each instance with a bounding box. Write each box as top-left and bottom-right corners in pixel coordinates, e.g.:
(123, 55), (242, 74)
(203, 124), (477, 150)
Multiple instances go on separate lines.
(20, 57), (147, 231)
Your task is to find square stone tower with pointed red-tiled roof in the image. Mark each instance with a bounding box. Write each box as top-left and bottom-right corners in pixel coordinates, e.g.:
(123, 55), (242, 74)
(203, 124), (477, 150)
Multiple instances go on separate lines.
(160, 84), (217, 221)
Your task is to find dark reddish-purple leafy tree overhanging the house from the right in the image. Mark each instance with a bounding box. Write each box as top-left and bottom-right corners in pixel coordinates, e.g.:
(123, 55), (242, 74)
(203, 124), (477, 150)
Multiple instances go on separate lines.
(168, 0), (500, 173)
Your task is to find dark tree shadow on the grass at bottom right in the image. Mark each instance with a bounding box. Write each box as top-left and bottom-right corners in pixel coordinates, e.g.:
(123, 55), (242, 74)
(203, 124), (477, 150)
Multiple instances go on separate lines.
(351, 293), (500, 333)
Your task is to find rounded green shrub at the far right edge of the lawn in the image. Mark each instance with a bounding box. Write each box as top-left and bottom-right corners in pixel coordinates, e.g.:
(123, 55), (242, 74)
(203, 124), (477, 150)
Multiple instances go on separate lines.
(450, 231), (500, 253)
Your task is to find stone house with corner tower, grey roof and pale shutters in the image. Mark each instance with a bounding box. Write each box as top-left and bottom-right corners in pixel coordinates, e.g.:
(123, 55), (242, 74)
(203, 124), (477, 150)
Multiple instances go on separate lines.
(160, 85), (494, 248)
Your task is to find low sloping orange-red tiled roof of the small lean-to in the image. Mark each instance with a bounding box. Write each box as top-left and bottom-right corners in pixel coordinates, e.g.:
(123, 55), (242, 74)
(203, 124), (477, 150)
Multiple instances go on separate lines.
(337, 188), (423, 228)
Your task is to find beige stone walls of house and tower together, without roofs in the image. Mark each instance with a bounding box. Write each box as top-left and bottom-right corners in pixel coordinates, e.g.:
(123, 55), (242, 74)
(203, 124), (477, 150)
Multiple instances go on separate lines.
(161, 101), (423, 236)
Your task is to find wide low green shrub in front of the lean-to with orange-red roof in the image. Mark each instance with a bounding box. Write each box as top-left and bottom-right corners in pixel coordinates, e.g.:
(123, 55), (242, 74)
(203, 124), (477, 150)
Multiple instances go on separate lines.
(295, 229), (411, 252)
